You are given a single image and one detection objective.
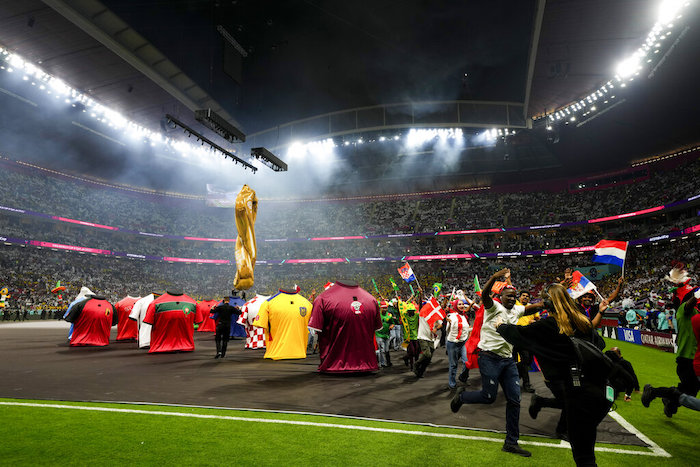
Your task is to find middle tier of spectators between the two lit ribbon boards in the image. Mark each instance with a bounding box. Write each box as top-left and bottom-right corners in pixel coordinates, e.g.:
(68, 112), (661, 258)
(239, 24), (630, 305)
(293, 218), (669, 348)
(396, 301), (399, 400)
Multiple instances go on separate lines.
(0, 208), (697, 260)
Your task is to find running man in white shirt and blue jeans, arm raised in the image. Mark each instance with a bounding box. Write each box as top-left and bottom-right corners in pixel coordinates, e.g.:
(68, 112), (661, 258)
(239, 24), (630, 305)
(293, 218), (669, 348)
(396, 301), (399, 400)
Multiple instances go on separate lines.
(450, 268), (535, 457)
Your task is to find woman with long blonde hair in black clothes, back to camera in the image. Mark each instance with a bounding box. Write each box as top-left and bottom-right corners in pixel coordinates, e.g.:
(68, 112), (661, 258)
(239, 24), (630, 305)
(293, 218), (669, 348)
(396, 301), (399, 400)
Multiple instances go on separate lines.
(496, 284), (612, 466)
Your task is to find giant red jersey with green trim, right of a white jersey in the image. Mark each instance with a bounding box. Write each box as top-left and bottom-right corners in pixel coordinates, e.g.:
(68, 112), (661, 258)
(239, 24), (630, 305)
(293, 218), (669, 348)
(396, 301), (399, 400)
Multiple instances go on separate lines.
(143, 293), (203, 353)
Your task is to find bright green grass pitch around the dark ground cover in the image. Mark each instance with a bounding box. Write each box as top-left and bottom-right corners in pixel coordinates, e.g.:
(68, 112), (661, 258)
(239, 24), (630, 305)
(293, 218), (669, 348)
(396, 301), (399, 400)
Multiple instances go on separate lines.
(0, 341), (700, 467)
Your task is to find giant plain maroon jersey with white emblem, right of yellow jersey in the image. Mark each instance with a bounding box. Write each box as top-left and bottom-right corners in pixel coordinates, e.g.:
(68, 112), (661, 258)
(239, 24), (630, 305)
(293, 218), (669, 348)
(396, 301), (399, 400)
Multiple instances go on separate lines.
(309, 282), (382, 373)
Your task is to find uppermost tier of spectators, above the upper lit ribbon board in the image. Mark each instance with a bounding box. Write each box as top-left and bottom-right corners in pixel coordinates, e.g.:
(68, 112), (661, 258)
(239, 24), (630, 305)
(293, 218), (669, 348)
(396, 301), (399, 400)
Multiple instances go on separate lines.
(0, 160), (700, 238)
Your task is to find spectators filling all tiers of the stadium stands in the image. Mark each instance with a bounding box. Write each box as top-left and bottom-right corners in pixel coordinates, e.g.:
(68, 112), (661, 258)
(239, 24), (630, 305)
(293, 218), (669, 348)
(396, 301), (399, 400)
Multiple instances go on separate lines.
(0, 155), (700, 326)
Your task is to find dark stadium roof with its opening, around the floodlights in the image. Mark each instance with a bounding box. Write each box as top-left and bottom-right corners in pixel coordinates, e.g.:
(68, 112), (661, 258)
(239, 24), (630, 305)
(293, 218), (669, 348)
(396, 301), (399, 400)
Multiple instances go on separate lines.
(0, 0), (698, 194)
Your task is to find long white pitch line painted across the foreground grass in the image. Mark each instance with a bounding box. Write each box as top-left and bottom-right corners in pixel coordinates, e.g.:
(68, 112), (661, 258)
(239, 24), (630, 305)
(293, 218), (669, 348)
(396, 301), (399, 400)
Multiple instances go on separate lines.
(0, 402), (671, 457)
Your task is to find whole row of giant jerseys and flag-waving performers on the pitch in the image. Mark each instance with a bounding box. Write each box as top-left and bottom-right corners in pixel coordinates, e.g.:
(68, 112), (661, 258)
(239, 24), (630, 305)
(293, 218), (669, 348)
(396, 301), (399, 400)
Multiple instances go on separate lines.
(65, 268), (700, 465)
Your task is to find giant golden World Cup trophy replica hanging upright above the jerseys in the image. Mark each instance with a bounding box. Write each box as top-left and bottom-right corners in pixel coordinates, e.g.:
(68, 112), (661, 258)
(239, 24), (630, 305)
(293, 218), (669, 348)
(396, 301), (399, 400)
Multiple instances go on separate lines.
(233, 185), (258, 290)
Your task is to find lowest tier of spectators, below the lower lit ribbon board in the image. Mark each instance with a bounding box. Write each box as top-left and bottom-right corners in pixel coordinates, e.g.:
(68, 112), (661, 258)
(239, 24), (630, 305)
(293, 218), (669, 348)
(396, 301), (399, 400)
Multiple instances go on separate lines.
(0, 236), (700, 327)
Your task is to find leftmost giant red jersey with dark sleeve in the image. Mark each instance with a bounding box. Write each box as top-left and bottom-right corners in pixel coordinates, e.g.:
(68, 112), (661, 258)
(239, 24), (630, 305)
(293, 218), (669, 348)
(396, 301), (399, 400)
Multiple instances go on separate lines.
(66, 297), (117, 346)
